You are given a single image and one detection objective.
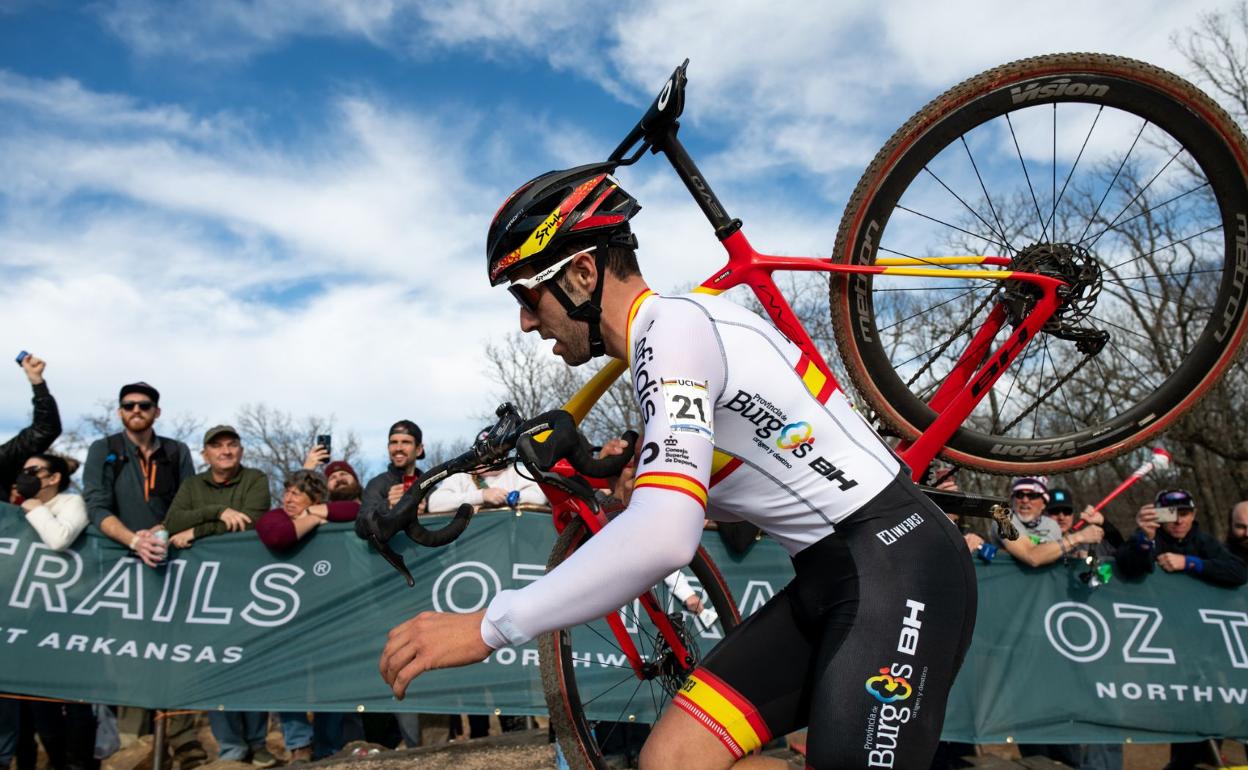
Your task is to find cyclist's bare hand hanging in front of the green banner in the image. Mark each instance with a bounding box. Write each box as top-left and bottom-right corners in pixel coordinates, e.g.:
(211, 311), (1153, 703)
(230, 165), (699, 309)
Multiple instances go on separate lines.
(379, 610), (494, 700)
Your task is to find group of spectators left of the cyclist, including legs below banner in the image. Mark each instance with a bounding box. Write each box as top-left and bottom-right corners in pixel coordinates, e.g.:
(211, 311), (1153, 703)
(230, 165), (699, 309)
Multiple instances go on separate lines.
(0, 356), (545, 770)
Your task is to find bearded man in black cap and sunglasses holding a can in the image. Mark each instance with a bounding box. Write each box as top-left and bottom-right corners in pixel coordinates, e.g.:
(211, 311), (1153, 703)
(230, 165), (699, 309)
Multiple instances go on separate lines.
(82, 382), (195, 567)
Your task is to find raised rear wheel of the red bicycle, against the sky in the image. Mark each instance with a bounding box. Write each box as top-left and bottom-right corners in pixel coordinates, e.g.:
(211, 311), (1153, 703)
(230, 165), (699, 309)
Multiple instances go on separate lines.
(830, 54), (1248, 473)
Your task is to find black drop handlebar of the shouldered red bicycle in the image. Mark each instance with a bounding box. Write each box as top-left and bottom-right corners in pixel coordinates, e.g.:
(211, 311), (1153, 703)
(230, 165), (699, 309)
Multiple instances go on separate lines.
(356, 403), (636, 587)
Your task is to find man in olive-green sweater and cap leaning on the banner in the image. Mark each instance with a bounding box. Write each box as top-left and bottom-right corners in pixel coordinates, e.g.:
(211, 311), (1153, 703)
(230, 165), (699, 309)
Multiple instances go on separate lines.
(165, 426), (270, 548)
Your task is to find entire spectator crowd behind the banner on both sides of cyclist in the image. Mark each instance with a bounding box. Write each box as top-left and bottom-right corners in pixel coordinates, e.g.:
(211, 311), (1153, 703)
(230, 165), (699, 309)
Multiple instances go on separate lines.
(0, 356), (1248, 770)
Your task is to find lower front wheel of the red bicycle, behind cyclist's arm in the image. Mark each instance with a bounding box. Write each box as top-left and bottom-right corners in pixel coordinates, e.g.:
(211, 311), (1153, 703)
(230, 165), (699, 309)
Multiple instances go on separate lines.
(538, 520), (740, 770)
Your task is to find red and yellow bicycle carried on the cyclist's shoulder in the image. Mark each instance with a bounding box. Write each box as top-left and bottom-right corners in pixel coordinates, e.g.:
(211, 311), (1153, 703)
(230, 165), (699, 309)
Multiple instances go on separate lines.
(359, 54), (1248, 768)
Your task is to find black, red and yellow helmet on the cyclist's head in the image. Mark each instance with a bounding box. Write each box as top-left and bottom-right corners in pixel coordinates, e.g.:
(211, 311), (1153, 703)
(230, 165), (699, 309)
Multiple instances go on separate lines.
(485, 162), (641, 286)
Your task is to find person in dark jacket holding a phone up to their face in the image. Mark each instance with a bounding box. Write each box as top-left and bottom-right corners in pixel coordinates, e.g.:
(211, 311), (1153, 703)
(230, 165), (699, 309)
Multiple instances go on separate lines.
(1117, 489), (1248, 587)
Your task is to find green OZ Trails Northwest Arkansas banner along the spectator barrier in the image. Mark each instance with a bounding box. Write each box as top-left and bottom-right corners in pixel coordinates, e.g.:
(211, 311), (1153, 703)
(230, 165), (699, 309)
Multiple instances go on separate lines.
(0, 505), (1248, 743)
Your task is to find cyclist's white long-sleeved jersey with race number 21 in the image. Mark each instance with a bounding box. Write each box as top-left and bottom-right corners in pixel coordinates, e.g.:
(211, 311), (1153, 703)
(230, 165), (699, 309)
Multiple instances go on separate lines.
(482, 291), (901, 648)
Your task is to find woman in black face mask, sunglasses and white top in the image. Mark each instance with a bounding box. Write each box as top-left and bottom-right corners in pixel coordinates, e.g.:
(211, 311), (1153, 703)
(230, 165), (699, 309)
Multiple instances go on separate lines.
(12, 453), (87, 550)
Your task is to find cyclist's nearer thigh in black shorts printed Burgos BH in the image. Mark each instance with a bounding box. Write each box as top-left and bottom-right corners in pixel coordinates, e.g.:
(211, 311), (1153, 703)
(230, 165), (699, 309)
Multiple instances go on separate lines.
(807, 480), (976, 770)
